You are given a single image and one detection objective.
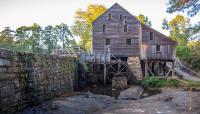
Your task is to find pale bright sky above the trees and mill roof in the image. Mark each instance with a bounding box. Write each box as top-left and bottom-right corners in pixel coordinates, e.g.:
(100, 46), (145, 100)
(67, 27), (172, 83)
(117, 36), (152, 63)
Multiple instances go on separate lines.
(0, 0), (200, 39)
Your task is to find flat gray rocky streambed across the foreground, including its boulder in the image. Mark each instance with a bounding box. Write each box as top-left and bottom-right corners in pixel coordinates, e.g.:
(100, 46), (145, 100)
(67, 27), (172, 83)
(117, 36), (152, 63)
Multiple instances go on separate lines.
(21, 86), (200, 114)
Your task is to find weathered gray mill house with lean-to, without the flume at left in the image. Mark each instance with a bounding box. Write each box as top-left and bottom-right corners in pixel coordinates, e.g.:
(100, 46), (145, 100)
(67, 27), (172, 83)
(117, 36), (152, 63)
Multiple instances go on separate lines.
(92, 3), (177, 75)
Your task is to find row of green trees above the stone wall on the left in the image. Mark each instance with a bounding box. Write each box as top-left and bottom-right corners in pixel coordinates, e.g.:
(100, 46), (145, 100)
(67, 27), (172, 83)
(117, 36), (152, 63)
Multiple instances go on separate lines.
(0, 23), (77, 54)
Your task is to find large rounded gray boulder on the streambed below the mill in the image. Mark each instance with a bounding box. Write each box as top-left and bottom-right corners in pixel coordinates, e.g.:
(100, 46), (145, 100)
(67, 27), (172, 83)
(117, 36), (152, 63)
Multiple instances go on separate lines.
(118, 86), (144, 100)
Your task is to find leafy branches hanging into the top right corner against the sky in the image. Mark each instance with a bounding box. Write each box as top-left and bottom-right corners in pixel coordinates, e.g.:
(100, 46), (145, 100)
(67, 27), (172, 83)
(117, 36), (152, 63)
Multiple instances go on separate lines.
(167, 0), (200, 17)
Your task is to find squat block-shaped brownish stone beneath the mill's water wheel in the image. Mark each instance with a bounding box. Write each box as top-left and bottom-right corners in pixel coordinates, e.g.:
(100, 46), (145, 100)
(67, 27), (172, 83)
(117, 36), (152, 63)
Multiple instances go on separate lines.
(112, 77), (127, 89)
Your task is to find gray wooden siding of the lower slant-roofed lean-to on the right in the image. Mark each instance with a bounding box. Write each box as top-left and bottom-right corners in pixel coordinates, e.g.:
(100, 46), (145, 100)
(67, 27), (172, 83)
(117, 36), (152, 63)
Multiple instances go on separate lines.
(140, 25), (176, 60)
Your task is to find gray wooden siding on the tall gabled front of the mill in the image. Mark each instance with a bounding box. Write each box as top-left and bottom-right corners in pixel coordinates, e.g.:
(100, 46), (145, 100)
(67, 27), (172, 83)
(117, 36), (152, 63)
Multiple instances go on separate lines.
(93, 4), (141, 57)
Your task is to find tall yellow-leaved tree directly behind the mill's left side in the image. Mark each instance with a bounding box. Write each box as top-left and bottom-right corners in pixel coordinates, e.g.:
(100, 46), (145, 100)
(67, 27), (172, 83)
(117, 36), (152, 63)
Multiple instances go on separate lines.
(72, 4), (106, 51)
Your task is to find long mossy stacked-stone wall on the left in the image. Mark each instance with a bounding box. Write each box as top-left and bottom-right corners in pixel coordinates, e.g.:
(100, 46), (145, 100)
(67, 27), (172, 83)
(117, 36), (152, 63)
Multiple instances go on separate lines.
(0, 50), (77, 114)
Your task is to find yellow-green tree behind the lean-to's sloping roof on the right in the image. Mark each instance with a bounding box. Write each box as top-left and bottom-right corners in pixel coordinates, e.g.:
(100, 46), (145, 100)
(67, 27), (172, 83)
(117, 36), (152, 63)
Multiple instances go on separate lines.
(162, 15), (191, 44)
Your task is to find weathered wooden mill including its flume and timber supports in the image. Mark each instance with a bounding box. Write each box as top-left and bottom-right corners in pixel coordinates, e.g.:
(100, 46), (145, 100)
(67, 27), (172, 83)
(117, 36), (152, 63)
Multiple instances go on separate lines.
(79, 3), (177, 81)
